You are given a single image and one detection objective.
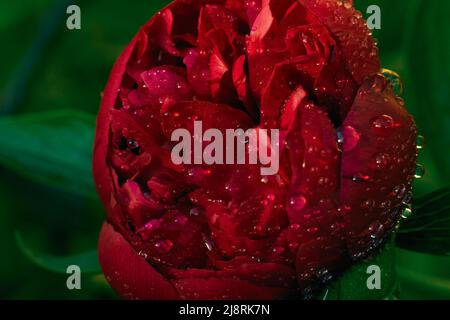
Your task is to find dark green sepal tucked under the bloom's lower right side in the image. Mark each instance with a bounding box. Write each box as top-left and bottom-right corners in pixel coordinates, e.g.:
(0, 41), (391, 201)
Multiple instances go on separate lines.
(322, 240), (396, 300)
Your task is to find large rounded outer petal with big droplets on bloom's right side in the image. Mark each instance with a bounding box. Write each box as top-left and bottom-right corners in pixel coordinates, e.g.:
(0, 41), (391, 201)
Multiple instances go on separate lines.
(341, 75), (417, 255)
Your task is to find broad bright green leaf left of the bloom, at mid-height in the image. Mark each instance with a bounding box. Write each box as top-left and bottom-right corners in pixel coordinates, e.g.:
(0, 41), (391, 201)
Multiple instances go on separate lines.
(0, 110), (96, 197)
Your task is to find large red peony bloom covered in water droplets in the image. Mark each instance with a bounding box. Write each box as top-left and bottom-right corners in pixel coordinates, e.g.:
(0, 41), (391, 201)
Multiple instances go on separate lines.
(93, 0), (416, 299)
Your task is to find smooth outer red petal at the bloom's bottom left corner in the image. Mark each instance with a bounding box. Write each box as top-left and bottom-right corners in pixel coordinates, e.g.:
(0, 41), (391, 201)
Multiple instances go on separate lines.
(98, 223), (178, 300)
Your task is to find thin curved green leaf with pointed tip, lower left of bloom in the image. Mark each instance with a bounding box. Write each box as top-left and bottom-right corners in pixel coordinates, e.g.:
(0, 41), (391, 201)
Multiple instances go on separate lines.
(15, 232), (101, 273)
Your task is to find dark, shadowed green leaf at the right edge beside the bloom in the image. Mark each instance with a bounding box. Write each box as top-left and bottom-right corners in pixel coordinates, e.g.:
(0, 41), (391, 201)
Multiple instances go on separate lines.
(396, 188), (450, 255)
